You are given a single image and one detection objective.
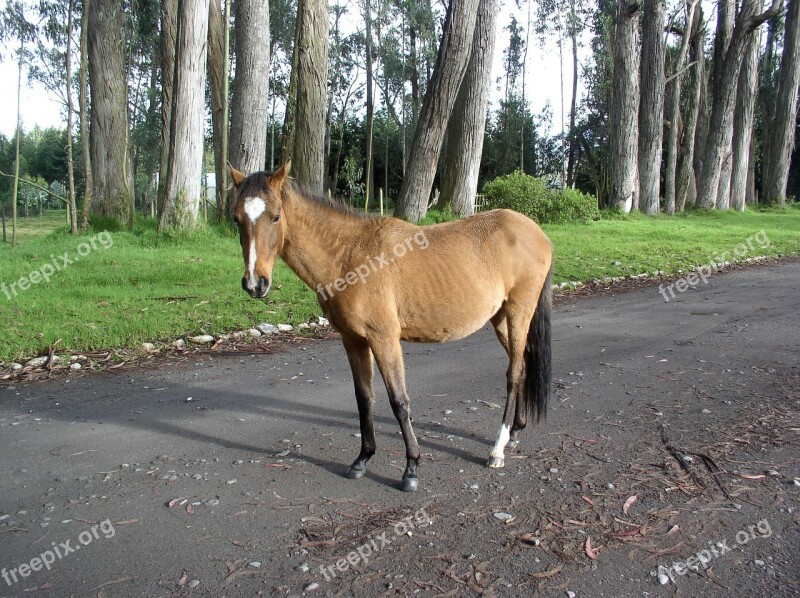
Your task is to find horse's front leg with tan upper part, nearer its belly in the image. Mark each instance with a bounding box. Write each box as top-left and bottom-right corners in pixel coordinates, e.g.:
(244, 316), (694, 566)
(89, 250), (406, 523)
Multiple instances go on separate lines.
(370, 335), (419, 492)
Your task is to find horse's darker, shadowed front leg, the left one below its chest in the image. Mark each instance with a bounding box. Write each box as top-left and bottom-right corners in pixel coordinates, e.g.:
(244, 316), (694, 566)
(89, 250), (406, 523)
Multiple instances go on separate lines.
(342, 336), (375, 480)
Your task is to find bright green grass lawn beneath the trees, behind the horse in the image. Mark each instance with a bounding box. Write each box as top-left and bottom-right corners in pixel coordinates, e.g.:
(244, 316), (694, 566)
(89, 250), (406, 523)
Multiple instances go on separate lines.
(0, 204), (800, 362)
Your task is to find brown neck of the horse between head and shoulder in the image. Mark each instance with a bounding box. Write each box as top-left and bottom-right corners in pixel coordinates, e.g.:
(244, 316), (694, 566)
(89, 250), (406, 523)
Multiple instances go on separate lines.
(280, 194), (359, 289)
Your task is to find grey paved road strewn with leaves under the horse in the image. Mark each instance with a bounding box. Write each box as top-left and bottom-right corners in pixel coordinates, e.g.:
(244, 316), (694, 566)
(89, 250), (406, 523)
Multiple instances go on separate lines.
(0, 263), (800, 596)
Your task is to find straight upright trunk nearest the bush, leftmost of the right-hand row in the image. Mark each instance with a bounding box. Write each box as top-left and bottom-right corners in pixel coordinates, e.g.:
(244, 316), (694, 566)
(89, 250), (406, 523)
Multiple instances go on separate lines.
(609, 0), (640, 213)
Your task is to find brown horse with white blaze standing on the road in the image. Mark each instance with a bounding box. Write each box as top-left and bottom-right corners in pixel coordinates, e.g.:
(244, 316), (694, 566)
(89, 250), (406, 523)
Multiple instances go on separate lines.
(231, 163), (552, 491)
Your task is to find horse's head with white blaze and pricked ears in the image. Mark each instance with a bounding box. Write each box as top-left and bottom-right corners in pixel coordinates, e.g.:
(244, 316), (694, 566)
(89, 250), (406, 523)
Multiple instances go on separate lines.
(230, 162), (291, 299)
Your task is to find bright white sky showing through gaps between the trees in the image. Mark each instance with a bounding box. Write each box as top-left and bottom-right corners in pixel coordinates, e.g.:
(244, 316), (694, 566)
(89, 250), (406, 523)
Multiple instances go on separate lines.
(0, 3), (581, 139)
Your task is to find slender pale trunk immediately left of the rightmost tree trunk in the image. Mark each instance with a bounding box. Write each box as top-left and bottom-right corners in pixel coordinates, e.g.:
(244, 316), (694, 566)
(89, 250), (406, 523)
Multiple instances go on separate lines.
(730, 20), (760, 212)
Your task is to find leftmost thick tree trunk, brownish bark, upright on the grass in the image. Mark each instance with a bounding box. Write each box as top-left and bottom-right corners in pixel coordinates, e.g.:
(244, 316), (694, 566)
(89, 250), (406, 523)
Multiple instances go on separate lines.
(89, 0), (134, 228)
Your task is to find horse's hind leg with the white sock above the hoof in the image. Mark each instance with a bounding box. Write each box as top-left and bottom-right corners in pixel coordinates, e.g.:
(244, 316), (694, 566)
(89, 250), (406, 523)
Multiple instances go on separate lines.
(486, 303), (532, 468)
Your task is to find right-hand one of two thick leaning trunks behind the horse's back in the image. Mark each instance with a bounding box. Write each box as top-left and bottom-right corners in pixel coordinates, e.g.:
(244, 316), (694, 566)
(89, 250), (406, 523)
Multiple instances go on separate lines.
(442, 0), (498, 217)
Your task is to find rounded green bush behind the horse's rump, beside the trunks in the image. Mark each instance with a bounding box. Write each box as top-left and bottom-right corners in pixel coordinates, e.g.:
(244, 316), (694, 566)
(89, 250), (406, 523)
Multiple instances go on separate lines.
(483, 170), (600, 224)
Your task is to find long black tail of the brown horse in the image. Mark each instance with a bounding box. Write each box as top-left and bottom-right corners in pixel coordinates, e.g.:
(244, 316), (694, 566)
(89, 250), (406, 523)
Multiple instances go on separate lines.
(523, 264), (553, 422)
